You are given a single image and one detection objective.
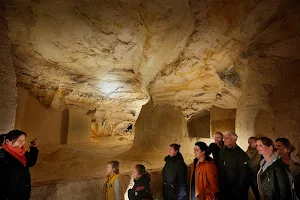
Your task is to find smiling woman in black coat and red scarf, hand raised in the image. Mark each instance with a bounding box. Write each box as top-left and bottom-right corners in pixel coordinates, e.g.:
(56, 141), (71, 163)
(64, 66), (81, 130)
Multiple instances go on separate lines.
(0, 130), (38, 200)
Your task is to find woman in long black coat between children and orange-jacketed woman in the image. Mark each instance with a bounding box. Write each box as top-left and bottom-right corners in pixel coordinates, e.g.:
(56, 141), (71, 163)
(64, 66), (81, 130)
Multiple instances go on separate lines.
(162, 144), (188, 200)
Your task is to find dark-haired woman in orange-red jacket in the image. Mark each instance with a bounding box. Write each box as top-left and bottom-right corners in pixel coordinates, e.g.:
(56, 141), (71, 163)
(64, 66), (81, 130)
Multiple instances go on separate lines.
(190, 142), (219, 200)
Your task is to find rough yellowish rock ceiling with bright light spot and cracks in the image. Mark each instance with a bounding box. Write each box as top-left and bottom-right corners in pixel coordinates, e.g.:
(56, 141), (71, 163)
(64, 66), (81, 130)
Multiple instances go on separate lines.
(6, 0), (300, 124)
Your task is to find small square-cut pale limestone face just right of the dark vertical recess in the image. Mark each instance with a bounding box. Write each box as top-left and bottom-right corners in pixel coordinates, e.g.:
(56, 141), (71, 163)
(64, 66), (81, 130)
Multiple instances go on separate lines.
(67, 109), (91, 144)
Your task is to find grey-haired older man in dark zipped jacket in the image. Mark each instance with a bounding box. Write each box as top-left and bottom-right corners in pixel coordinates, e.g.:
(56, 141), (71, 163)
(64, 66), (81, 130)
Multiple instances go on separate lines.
(219, 132), (251, 200)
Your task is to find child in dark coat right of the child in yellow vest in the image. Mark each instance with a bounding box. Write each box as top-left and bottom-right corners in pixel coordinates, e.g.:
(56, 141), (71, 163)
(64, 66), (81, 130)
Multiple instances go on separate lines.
(128, 164), (153, 200)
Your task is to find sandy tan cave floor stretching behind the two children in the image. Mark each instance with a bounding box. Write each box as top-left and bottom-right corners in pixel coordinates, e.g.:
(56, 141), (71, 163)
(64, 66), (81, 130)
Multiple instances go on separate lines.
(31, 136), (193, 185)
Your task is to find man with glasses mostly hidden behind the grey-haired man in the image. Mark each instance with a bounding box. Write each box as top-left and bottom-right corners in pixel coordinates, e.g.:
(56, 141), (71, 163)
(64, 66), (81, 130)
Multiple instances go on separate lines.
(207, 132), (224, 167)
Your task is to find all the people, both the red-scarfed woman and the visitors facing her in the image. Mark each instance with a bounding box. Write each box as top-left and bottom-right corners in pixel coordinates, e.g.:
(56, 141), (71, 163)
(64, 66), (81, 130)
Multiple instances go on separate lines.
(0, 130), (300, 200)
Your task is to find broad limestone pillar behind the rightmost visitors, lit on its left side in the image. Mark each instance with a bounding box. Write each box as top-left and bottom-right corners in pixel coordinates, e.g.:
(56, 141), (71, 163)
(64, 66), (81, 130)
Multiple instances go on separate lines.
(236, 58), (300, 150)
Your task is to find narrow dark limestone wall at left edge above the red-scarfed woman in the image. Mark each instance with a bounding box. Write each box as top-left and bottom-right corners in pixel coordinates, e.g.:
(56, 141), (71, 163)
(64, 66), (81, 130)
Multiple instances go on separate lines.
(0, 0), (17, 133)
